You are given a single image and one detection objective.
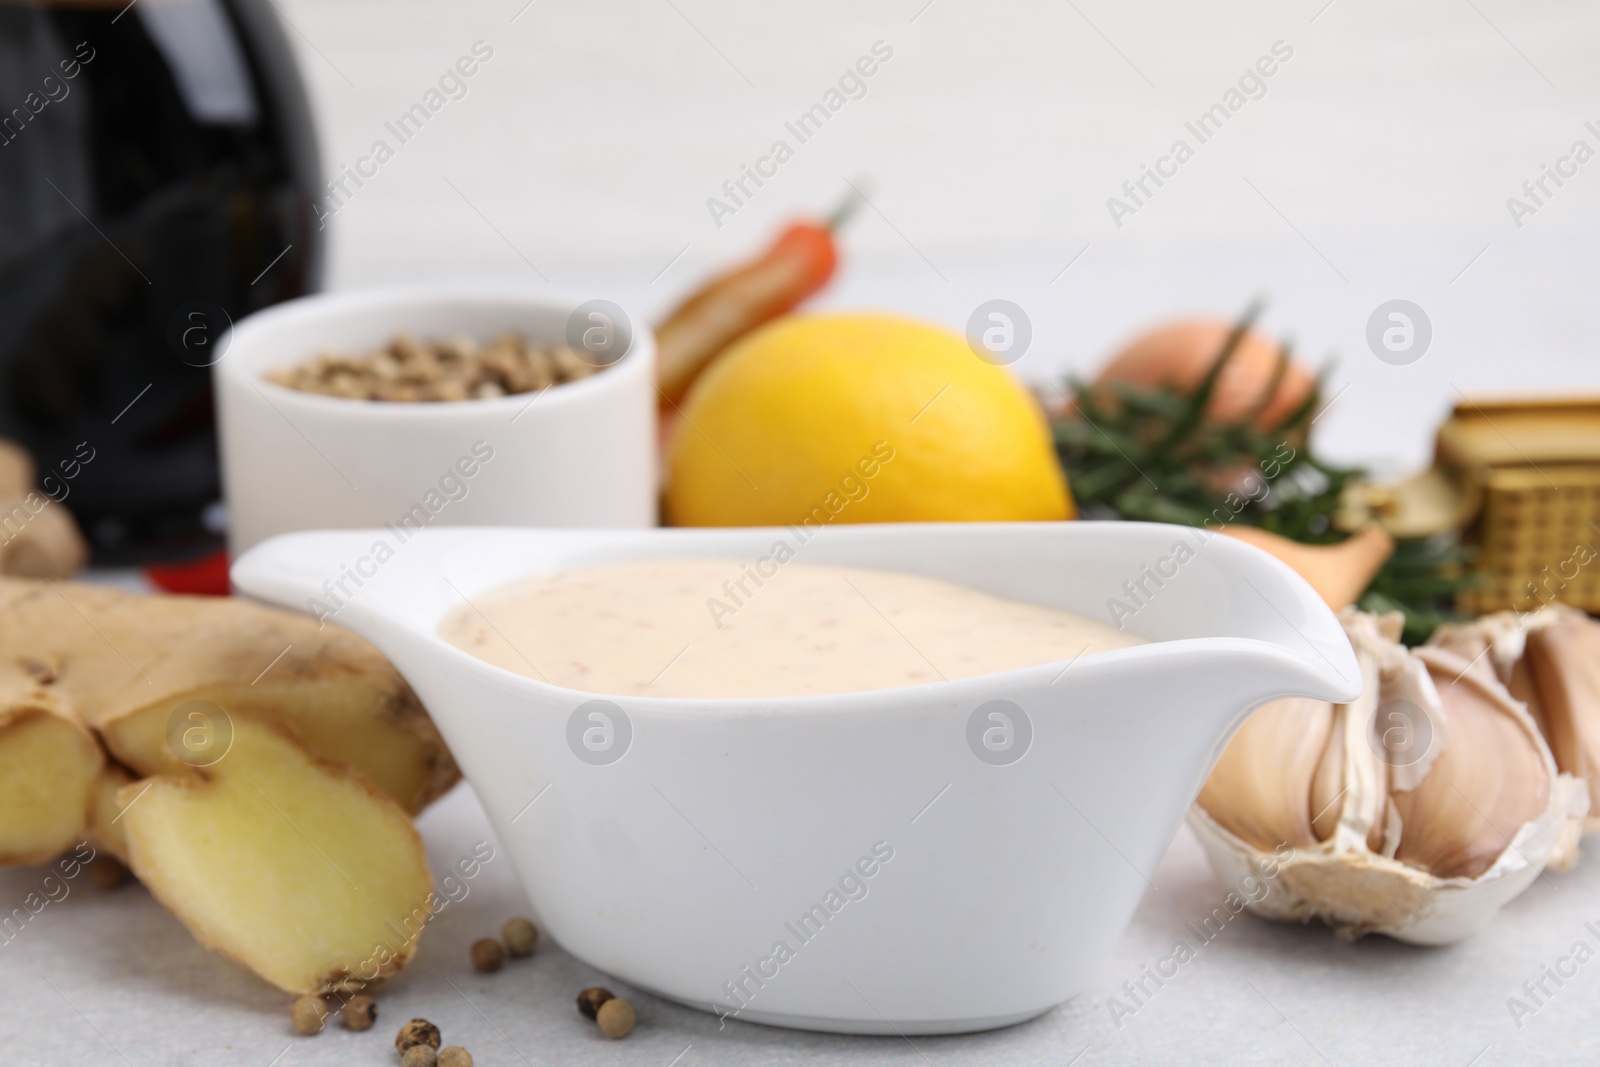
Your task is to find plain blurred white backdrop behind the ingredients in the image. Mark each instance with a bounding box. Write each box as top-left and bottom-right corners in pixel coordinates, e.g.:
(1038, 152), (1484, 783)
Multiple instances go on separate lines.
(277, 0), (1600, 467)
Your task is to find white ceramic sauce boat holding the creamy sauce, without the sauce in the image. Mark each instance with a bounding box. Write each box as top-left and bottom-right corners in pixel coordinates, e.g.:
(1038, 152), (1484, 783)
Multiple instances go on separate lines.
(234, 522), (1360, 1033)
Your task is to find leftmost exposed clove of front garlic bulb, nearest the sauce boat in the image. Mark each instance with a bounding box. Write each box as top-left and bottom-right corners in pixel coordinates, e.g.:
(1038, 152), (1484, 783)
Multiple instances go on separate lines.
(1200, 697), (1333, 849)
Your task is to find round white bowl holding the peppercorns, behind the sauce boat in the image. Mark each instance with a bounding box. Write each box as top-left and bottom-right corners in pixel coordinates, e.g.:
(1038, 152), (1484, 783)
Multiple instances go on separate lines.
(214, 285), (656, 550)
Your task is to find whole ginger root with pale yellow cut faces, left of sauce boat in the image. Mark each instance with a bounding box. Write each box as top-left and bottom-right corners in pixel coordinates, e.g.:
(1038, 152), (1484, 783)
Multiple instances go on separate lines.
(0, 577), (459, 995)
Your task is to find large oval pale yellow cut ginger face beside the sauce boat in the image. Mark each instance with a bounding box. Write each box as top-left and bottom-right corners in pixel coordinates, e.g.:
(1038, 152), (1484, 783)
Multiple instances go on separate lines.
(118, 717), (432, 995)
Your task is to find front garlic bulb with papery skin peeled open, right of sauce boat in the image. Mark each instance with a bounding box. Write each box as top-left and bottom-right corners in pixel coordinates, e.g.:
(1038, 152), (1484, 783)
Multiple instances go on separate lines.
(1190, 609), (1589, 944)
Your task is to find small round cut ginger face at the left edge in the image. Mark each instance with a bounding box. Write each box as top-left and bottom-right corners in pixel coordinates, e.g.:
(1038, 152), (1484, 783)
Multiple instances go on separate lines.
(0, 694), (106, 864)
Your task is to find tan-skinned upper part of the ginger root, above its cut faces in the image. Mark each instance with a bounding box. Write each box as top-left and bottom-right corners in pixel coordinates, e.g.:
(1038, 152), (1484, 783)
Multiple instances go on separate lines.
(0, 579), (461, 825)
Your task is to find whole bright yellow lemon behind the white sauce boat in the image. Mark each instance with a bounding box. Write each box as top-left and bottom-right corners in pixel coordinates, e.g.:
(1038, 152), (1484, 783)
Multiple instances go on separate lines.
(666, 314), (1074, 526)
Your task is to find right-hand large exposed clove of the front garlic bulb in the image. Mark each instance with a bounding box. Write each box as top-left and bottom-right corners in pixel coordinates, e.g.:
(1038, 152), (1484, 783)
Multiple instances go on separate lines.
(1394, 651), (1554, 878)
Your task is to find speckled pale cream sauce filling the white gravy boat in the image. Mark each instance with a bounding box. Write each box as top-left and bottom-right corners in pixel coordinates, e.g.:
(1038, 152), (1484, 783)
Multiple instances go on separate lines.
(438, 558), (1144, 697)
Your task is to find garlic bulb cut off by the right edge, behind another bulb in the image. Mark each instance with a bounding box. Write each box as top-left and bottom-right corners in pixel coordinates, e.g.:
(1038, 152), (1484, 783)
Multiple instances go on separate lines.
(1429, 605), (1600, 832)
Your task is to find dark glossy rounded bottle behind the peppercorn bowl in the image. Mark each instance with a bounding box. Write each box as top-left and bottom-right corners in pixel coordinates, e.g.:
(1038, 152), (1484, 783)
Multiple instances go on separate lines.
(0, 0), (322, 565)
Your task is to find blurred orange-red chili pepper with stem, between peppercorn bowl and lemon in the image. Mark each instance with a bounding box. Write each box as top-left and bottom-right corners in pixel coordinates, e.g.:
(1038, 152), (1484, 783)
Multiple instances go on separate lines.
(656, 197), (859, 406)
